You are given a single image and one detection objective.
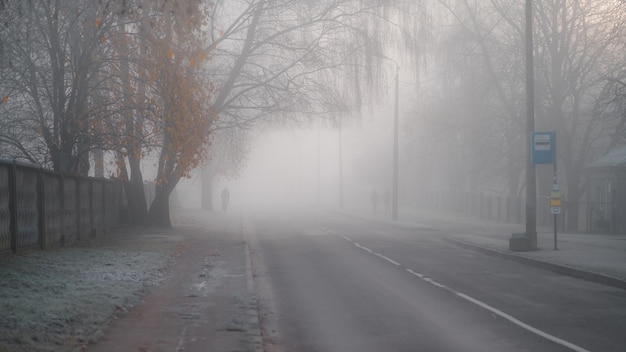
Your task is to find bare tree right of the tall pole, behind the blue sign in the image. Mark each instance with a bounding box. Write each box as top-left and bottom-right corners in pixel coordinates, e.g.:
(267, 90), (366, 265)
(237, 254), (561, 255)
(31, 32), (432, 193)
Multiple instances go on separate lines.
(536, 0), (626, 230)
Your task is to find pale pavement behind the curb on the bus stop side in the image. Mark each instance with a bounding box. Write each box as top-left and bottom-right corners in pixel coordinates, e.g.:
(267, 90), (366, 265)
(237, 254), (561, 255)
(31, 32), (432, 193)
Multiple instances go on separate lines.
(336, 209), (626, 289)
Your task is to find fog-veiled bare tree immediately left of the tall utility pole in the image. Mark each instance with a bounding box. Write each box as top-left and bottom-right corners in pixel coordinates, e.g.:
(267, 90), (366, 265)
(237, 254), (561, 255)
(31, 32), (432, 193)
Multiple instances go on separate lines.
(414, 0), (525, 196)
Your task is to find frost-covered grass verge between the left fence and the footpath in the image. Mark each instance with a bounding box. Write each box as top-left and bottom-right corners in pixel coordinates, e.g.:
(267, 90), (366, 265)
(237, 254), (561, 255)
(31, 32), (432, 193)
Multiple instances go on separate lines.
(0, 229), (183, 352)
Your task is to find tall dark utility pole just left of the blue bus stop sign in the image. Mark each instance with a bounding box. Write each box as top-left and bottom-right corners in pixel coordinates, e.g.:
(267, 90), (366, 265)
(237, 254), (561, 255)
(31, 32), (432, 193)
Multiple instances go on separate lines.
(526, 0), (537, 249)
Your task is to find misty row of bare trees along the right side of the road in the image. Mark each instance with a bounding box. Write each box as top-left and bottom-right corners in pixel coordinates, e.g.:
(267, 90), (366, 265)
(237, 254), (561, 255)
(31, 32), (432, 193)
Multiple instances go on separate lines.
(404, 0), (626, 229)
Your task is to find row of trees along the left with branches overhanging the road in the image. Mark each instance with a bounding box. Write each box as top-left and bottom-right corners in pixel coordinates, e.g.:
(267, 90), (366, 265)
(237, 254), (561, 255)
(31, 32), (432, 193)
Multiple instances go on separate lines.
(0, 0), (420, 226)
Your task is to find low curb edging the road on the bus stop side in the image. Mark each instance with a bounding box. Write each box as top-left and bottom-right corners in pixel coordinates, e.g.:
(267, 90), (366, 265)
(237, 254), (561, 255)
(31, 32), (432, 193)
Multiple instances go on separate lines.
(442, 237), (626, 290)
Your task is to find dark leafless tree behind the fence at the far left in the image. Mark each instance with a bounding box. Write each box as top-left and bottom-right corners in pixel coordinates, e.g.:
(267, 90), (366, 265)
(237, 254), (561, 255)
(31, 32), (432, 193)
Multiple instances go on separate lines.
(3, 0), (116, 174)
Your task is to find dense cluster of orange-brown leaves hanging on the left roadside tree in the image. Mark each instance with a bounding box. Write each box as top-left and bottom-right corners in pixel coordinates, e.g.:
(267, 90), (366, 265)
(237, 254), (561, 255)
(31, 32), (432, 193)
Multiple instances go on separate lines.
(146, 25), (214, 185)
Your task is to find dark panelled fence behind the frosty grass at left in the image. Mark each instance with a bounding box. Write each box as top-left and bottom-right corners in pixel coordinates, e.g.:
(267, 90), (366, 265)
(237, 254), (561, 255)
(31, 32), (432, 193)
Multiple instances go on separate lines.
(0, 159), (122, 253)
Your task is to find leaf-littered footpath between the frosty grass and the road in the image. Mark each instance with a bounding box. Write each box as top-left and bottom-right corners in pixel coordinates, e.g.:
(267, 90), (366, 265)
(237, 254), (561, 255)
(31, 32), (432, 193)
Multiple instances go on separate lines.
(86, 210), (262, 352)
